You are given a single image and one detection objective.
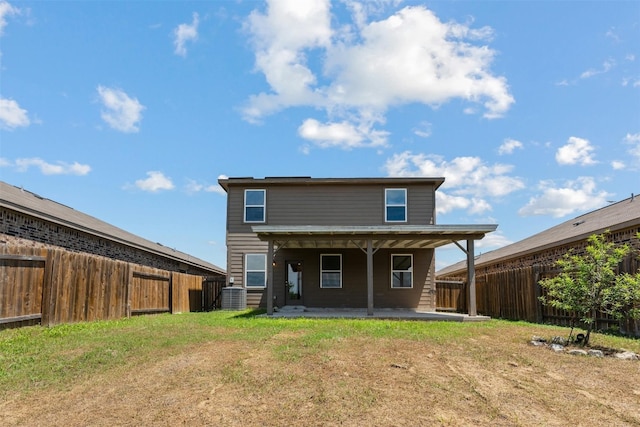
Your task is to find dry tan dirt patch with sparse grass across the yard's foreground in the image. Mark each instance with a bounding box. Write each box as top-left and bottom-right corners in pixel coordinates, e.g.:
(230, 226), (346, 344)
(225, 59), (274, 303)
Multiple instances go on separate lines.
(0, 326), (640, 426)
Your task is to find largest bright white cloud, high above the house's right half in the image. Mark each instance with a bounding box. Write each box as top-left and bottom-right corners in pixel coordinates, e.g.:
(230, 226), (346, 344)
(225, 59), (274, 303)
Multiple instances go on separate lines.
(326, 7), (513, 118)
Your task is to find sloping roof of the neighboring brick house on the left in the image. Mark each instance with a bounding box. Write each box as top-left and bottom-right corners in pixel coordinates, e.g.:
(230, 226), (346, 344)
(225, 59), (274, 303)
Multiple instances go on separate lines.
(0, 181), (226, 274)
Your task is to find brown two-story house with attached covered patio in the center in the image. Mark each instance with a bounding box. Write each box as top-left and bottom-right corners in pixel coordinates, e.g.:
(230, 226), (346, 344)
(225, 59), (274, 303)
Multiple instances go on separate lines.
(218, 177), (497, 315)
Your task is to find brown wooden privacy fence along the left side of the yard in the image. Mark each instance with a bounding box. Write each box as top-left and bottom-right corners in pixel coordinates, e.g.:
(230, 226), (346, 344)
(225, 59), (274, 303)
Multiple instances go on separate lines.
(0, 247), (224, 328)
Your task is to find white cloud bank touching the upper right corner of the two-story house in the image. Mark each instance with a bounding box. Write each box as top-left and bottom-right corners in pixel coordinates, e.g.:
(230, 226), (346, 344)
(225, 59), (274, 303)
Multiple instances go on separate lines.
(384, 151), (524, 214)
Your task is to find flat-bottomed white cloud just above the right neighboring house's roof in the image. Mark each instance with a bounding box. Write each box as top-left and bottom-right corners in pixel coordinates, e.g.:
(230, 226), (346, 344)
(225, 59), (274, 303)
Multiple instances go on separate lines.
(518, 177), (611, 218)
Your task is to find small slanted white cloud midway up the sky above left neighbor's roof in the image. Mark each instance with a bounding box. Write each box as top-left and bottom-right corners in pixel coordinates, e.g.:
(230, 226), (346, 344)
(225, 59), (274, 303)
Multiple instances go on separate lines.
(97, 85), (145, 133)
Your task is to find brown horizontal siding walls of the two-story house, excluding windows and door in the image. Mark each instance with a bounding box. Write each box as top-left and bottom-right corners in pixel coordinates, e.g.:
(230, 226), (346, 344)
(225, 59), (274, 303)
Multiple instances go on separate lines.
(222, 182), (435, 310)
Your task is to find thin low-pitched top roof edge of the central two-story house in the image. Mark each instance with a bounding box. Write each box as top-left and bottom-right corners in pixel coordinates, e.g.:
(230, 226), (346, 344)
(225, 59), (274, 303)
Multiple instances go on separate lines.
(218, 176), (444, 191)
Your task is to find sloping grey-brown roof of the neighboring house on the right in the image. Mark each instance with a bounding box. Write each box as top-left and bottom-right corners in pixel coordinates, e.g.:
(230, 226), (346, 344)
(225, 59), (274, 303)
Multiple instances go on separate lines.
(436, 195), (640, 276)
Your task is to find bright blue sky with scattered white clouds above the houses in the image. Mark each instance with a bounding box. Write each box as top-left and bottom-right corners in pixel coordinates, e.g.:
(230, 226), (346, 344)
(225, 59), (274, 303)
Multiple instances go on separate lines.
(0, 0), (640, 268)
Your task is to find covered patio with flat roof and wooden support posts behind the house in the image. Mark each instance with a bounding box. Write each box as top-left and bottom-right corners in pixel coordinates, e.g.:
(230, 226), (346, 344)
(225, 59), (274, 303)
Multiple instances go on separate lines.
(252, 224), (497, 318)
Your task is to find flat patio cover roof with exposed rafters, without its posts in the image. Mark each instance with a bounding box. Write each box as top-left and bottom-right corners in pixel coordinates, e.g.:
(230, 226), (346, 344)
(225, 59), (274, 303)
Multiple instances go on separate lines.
(252, 224), (498, 249)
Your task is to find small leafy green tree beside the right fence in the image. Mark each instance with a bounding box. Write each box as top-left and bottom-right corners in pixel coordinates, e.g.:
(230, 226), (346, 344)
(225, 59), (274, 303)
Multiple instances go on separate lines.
(539, 231), (640, 345)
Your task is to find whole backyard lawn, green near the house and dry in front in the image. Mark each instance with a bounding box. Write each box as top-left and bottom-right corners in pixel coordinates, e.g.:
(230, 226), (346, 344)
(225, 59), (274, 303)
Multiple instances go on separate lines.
(0, 311), (640, 425)
